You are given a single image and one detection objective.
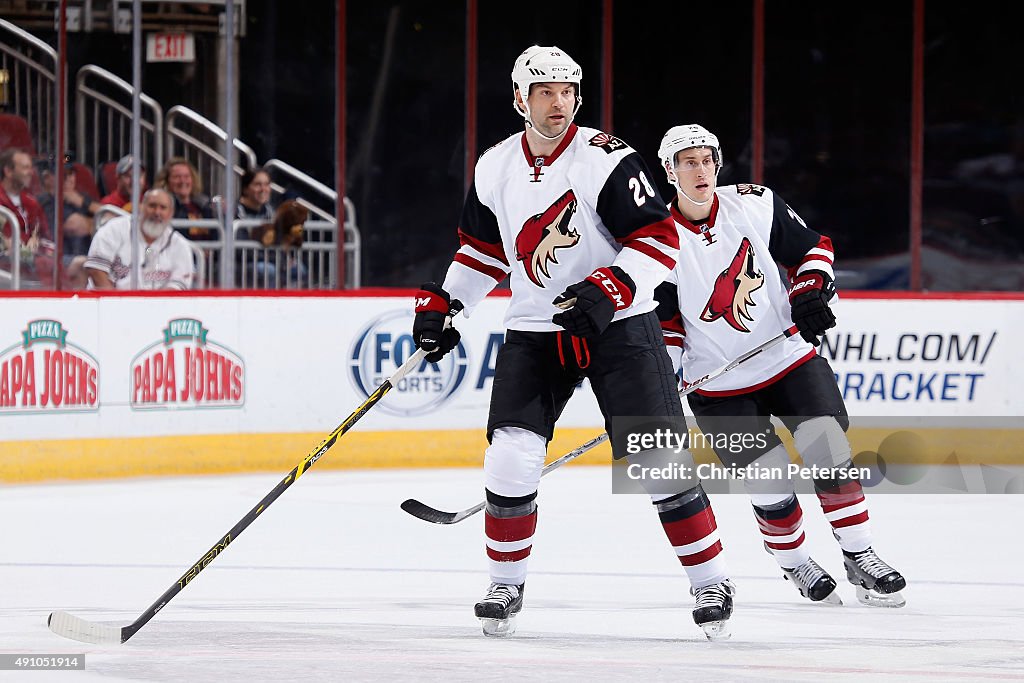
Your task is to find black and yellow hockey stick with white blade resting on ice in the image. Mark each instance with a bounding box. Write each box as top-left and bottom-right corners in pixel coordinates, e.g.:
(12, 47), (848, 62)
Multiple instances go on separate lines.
(46, 301), (462, 645)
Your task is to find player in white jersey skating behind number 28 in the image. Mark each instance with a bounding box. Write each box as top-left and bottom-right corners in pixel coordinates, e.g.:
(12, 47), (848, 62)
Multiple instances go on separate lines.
(656, 125), (906, 607)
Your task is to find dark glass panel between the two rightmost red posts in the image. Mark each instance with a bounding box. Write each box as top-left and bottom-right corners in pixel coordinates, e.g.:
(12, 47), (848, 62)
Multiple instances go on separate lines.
(765, 2), (912, 289)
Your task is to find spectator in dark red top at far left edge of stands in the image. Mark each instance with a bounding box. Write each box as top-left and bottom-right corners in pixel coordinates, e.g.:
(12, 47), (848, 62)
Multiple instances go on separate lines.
(0, 148), (53, 286)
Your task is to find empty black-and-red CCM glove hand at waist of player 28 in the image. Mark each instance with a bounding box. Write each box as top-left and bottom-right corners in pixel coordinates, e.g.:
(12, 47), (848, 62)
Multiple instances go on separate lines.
(551, 265), (637, 337)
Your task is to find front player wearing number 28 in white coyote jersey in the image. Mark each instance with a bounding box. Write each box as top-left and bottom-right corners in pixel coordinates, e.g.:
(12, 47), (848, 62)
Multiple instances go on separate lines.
(413, 46), (734, 638)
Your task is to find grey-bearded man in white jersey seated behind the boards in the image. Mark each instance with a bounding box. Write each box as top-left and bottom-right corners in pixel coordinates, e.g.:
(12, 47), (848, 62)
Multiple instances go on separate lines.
(85, 187), (196, 290)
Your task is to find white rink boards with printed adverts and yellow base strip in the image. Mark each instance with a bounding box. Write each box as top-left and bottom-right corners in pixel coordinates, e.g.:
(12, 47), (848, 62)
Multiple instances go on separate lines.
(0, 290), (1024, 481)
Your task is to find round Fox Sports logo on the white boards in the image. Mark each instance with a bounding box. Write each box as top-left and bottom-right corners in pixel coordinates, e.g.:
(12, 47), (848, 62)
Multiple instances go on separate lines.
(349, 310), (469, 418)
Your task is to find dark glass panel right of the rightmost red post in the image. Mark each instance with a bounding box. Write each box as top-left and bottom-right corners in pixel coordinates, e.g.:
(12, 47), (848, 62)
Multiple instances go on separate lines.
(922, 2), (1024, 291)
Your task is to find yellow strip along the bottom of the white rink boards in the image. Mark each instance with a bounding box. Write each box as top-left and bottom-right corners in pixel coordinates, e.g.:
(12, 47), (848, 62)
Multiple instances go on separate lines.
(0, 424), (1024, 483)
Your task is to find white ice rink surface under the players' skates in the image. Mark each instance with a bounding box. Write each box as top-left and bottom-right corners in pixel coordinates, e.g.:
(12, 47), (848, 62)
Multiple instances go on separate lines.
(0, 466), (1024, 683)
